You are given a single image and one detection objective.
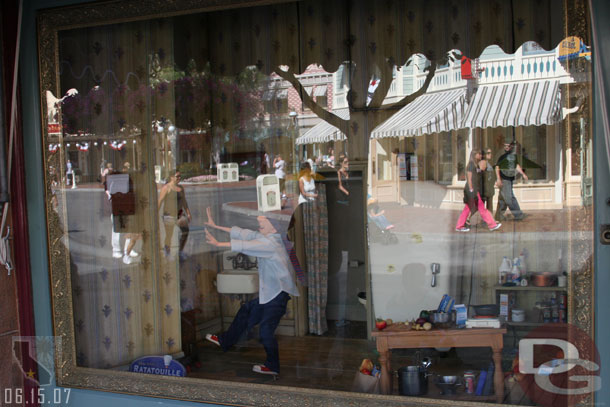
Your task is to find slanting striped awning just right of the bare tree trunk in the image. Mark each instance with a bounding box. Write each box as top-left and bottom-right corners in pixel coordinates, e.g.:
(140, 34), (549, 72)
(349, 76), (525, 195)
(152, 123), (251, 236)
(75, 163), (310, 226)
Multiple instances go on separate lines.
(371, 88), (466, 138)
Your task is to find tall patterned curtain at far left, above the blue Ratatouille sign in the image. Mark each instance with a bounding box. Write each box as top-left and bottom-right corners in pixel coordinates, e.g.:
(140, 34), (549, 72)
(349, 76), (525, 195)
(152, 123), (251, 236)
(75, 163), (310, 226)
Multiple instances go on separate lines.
(56, 20), (183, 368)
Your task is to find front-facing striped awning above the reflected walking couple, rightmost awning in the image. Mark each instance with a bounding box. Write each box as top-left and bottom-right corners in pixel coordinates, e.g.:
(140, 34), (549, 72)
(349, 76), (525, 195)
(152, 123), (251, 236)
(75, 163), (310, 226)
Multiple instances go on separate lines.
(462, 80), (561, 128)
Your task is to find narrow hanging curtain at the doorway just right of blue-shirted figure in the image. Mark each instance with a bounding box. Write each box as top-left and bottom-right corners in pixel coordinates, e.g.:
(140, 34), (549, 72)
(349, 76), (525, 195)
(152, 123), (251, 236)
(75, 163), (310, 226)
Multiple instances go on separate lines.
(299, 184), (328, 335)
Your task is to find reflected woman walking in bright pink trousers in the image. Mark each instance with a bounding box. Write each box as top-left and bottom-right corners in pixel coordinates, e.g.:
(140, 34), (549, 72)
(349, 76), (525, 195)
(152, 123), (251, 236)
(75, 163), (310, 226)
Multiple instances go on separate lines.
(455, 150), (502, 232)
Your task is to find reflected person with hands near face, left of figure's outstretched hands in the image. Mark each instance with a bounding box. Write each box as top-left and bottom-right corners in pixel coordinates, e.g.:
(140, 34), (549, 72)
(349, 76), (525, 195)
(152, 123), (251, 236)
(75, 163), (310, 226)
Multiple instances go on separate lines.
(159, 171), (191, 260)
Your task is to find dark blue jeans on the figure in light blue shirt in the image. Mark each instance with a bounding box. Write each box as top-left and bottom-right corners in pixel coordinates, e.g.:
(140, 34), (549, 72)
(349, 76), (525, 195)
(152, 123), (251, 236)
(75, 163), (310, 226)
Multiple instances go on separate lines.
(218, 291), (290, 373)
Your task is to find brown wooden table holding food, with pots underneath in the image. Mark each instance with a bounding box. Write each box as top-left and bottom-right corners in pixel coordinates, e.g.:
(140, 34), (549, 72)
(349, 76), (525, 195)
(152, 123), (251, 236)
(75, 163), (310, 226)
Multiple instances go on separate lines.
(372, 325), (506, 403)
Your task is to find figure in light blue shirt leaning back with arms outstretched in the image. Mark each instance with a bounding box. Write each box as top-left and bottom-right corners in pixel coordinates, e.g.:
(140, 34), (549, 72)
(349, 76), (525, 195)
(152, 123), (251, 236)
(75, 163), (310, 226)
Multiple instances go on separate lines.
(206, 208), (299, 375)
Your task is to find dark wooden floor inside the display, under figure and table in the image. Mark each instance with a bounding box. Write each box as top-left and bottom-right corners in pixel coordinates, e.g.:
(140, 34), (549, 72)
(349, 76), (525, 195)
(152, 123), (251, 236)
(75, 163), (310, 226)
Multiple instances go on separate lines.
(189, 326), (516, 401)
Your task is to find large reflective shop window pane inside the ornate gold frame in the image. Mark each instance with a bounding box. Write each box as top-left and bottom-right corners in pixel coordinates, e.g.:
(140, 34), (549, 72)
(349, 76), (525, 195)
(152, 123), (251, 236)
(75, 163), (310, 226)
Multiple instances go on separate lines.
(43, 4), (593, 405)
